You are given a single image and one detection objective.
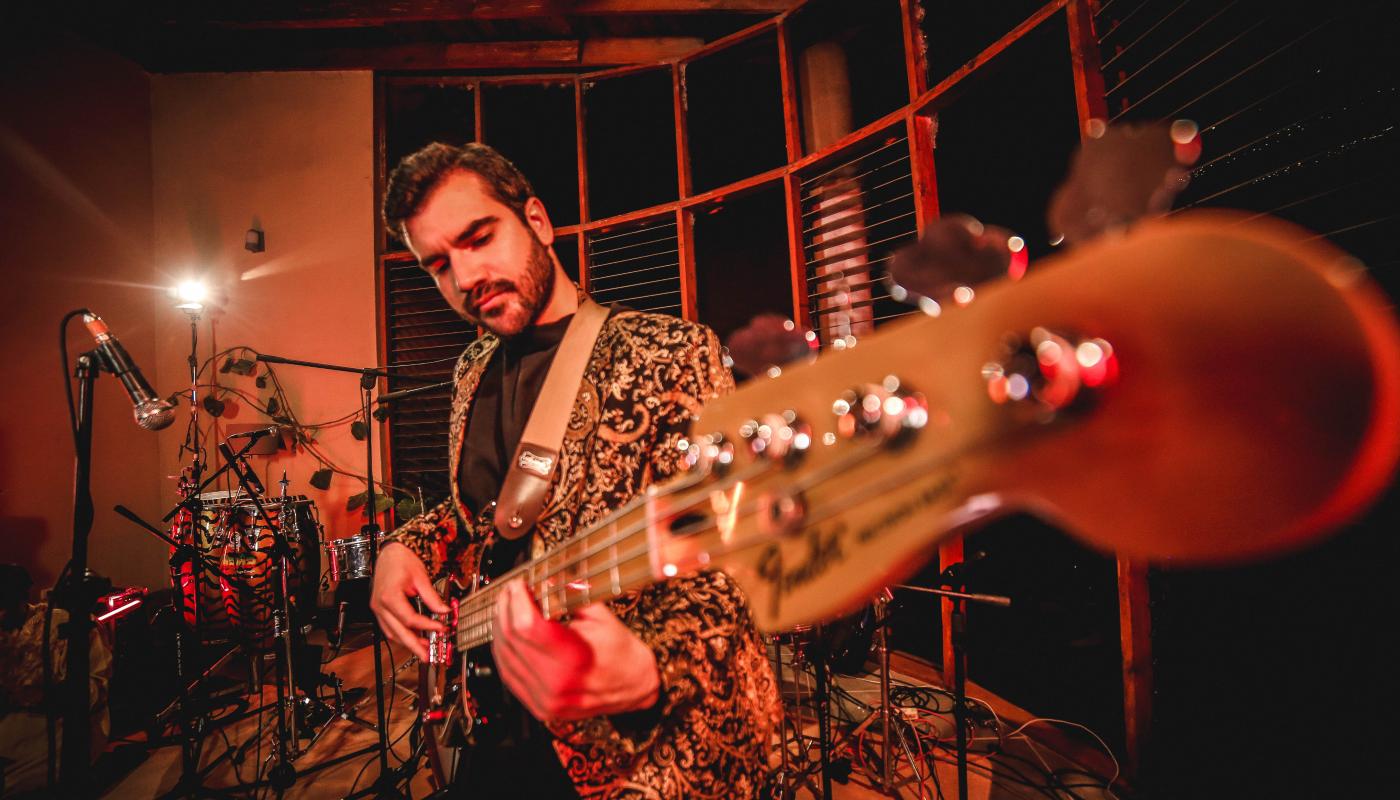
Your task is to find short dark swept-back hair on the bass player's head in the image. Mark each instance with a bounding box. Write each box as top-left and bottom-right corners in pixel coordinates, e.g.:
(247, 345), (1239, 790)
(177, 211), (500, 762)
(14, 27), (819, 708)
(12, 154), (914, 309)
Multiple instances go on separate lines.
(384, 142), (535, 238)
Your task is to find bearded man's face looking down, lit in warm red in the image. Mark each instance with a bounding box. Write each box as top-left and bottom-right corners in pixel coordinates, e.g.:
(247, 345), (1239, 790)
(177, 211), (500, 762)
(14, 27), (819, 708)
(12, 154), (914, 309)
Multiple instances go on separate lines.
(406, 171), (554, 336)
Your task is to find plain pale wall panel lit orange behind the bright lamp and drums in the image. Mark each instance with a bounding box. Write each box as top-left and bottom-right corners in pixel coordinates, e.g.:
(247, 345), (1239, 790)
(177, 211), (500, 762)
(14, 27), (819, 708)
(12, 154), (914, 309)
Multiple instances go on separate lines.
(151, 71), (379, 557)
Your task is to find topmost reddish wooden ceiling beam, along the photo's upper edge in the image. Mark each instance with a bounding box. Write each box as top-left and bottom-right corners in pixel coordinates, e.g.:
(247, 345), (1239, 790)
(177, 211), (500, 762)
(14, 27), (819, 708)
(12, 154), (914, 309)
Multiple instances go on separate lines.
(151, 0), (798, 29)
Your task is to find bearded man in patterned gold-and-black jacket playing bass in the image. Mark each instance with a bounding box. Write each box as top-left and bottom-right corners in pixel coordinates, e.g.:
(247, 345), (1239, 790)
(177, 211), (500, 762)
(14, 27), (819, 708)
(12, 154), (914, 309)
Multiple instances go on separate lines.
(371, 144), (778, 799)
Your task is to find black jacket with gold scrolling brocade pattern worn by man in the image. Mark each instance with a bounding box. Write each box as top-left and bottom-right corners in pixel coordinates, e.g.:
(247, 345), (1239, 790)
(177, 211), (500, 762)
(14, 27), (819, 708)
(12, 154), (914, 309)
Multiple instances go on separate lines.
(389, 311), (778, 799)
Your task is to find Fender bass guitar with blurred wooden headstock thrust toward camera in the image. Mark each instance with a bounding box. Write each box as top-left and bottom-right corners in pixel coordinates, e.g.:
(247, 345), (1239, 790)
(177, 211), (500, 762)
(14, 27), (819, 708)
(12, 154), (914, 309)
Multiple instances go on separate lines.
(421, 212), (1400, 780)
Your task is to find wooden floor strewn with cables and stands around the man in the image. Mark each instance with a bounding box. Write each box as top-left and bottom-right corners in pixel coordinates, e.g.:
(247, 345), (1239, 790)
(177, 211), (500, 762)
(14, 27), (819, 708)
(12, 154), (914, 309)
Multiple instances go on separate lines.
(87, 636), (1114, 800)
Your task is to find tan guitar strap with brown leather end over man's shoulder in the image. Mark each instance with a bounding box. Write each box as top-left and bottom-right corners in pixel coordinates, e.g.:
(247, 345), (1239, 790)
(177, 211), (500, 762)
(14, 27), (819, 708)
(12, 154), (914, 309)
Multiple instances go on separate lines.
(496, 297), (608, 539)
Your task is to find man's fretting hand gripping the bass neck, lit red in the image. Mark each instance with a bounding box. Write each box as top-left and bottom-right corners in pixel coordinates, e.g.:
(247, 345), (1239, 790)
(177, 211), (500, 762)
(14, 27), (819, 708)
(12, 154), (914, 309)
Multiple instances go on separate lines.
(492, 580), (661, 722)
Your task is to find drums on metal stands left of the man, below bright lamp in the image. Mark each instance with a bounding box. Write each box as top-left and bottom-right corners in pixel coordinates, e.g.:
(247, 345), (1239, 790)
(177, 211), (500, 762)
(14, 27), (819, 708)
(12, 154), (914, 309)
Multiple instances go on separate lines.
(162, 443), (400, 793)
